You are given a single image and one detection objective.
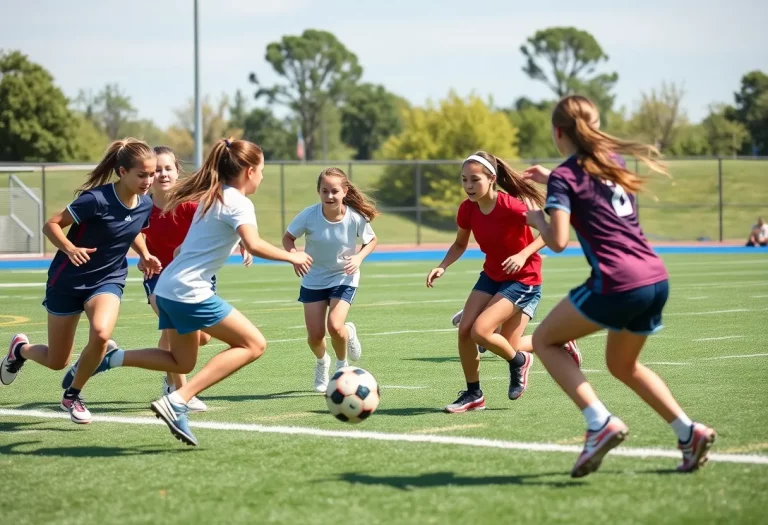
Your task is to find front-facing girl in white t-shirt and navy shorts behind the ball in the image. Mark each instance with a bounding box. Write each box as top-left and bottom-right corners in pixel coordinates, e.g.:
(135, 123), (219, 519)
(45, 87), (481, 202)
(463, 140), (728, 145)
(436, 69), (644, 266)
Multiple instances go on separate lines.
(283, 168), (378, 392)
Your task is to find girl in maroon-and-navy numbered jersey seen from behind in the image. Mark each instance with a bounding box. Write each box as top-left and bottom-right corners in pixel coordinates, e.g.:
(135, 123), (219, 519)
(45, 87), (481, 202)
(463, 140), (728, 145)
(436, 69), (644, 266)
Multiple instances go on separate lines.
(526, 95), (716, 477)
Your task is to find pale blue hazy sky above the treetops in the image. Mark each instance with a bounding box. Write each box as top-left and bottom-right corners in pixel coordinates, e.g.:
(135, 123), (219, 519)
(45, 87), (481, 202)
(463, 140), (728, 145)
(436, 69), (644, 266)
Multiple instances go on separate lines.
(0, 0), (768, 126)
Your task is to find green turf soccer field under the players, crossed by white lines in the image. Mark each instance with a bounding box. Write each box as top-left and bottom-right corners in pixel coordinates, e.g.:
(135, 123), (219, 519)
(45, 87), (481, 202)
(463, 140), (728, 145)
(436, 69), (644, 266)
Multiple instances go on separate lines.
(0, 252), (768, 525)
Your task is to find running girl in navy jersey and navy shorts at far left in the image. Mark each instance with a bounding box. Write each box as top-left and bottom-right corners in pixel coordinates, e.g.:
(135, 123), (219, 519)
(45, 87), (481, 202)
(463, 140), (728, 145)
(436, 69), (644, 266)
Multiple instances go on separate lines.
(0, 138), (162, 424)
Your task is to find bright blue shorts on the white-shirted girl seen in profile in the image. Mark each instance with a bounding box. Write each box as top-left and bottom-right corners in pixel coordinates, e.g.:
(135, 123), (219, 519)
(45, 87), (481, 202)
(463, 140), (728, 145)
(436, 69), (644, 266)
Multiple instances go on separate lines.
(157, 295), (232, 335)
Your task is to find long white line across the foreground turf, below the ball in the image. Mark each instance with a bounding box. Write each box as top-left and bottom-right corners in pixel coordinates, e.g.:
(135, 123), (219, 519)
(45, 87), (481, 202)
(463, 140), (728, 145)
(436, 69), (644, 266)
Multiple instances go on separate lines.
(0, 409), (768, 465)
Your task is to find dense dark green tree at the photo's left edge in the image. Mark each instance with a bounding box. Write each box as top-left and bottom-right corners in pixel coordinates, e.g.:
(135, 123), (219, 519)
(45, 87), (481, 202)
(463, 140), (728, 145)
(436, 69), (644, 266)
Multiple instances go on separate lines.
(0, 51), (81, 162)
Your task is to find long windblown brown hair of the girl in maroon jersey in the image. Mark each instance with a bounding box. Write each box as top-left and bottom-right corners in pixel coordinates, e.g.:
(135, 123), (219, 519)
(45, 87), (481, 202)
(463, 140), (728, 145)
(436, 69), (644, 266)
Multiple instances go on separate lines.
(552, 95), (668, 193)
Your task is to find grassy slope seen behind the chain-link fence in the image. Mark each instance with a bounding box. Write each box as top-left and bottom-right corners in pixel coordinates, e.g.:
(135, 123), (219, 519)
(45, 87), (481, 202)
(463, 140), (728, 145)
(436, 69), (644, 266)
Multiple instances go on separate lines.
(0, 159), (768, 243)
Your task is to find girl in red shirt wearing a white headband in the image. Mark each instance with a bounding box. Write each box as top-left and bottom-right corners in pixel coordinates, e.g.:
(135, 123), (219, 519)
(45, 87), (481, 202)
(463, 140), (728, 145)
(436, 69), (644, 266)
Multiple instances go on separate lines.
(427, 151), (580, 413)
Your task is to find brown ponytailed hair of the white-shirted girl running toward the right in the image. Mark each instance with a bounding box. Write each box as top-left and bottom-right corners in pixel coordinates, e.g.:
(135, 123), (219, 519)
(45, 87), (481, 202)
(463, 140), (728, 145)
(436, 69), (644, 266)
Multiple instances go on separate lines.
(165, 139), (264, 216)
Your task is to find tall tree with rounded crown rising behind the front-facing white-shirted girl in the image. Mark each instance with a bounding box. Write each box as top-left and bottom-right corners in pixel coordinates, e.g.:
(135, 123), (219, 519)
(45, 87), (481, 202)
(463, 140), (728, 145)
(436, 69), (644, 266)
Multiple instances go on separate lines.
(250, 29), (363, 159)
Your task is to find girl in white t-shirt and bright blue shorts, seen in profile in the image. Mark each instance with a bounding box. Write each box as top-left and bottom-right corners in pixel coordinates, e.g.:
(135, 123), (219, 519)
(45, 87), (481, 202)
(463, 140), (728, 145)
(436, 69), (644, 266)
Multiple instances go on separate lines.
(73, 140), (312, 445)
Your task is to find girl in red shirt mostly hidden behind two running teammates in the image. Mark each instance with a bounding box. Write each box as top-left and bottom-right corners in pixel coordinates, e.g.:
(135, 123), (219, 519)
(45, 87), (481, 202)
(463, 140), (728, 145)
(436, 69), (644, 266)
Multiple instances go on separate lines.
(139, 146), (253, 412)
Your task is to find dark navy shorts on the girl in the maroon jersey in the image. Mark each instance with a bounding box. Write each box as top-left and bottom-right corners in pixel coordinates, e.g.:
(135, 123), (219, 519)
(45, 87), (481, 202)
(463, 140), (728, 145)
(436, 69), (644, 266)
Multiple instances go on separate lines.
(568, 281), (669, 335)
